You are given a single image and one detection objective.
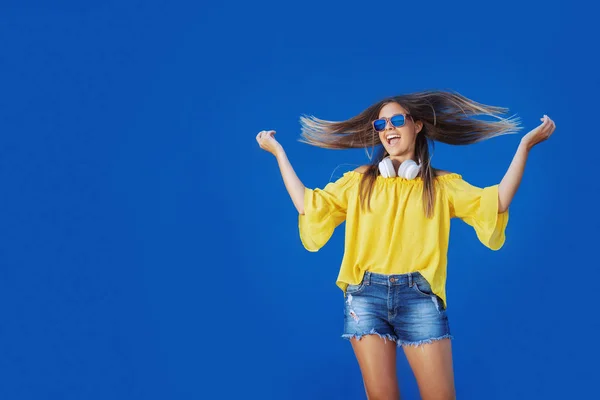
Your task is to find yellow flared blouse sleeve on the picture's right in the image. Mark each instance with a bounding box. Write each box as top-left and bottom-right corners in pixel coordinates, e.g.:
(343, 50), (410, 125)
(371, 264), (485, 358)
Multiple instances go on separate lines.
(448, 178), (508, 250)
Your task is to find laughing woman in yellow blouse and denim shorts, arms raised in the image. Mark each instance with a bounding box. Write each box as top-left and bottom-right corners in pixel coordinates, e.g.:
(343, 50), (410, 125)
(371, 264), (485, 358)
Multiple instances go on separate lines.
(256, 91), (555, 399)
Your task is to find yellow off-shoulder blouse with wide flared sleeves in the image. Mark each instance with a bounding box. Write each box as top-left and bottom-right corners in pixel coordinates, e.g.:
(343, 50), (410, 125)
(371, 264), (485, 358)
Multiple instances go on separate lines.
(298, 171), (508, 305)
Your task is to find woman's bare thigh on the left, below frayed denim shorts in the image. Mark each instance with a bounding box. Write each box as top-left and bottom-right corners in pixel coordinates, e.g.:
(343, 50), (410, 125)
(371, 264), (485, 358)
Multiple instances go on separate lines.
(350, 335), (400, 400)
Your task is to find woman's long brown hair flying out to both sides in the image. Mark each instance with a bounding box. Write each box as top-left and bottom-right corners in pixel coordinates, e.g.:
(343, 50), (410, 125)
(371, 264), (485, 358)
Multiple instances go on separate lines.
(299, 90), (521, 218)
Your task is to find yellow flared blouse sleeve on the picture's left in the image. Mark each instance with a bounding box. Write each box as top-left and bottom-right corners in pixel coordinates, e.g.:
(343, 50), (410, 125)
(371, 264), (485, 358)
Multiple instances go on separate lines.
(298, 172), (352, 252)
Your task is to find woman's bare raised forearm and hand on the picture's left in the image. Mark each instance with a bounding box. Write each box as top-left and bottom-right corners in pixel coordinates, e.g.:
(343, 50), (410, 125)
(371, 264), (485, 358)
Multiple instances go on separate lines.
(256, 131), (306, 214)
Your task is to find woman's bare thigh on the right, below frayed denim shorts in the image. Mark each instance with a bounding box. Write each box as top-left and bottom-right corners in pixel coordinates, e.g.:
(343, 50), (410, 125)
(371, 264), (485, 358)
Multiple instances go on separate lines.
(402, 339), (456, 400)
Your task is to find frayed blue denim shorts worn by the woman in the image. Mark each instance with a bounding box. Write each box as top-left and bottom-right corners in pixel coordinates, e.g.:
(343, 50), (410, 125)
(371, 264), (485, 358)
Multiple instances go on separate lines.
(342, 271), (453, 346)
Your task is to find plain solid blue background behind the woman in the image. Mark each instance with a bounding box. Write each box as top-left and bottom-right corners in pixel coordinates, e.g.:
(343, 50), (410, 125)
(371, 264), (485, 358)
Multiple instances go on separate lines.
(0, 0), (600, 399)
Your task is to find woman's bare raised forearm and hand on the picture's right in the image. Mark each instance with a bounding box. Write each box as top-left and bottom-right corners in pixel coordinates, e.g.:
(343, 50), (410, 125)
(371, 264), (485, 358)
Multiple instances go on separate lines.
(498, 115), (556, 213)
